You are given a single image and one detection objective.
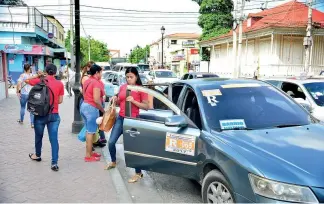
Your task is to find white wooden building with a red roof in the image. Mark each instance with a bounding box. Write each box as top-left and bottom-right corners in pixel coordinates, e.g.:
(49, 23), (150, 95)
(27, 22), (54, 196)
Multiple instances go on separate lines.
(200, 1), (324, 77)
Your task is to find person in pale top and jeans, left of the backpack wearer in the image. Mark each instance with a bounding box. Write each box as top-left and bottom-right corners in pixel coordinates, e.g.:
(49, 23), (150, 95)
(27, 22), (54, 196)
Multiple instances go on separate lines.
(17, 64), (34, 128)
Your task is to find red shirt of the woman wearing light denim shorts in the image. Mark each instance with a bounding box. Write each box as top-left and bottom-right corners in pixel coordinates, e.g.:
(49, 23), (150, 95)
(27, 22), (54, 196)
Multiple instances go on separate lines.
(82, 77), (105, 107)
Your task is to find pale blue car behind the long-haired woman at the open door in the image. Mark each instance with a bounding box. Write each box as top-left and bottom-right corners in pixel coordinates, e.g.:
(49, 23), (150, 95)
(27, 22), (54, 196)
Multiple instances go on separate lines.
(103, 72), (148, 101)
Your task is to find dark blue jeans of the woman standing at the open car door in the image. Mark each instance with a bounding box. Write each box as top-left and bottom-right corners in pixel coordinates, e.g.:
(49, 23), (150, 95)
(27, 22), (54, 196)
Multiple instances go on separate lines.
(108, 116), (141, 174)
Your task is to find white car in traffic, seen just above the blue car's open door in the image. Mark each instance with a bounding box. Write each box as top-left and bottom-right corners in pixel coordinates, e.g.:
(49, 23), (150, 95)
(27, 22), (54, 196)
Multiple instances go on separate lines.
(148, 69), (178, 84)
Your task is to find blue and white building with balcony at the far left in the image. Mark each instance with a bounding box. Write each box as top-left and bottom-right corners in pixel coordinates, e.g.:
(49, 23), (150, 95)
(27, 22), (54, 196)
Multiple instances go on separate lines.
(0, 6), (65, 99)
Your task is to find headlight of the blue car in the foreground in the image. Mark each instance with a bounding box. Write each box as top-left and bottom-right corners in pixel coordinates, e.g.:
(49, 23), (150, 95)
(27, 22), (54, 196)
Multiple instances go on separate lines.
(249, 174), (318, 203)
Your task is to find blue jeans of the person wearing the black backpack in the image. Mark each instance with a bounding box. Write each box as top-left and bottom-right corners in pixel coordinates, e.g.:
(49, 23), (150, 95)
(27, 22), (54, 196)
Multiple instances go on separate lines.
(34, 113), (61, 165)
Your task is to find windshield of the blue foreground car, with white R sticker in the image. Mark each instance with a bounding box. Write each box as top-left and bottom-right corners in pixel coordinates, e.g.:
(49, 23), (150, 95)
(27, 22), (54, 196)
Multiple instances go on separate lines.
(200, 84), (311, 131)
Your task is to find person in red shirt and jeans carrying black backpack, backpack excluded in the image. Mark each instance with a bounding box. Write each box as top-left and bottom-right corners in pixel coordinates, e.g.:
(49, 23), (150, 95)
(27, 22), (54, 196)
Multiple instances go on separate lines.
(25, 63), (64, 171)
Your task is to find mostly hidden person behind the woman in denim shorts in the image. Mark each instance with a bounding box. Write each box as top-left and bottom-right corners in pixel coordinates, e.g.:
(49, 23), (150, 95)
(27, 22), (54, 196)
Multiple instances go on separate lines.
(80, 61), (107, 148)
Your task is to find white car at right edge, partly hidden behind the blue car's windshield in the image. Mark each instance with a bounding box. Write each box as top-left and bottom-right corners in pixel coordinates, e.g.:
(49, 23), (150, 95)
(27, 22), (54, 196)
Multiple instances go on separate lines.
(264, 79), (324, 121)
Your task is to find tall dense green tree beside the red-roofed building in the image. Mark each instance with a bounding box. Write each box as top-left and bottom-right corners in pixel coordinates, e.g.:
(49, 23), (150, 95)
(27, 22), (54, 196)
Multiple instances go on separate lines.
(193, 0), (233, 40)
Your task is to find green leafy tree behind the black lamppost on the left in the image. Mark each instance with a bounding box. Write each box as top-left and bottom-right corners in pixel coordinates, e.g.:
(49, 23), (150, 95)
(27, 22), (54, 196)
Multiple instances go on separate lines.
(65, 30), (109, 65)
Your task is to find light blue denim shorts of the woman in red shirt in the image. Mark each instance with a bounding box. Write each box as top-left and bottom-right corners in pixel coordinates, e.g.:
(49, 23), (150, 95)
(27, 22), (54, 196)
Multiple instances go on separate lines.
(80, 102), (99, 134)
